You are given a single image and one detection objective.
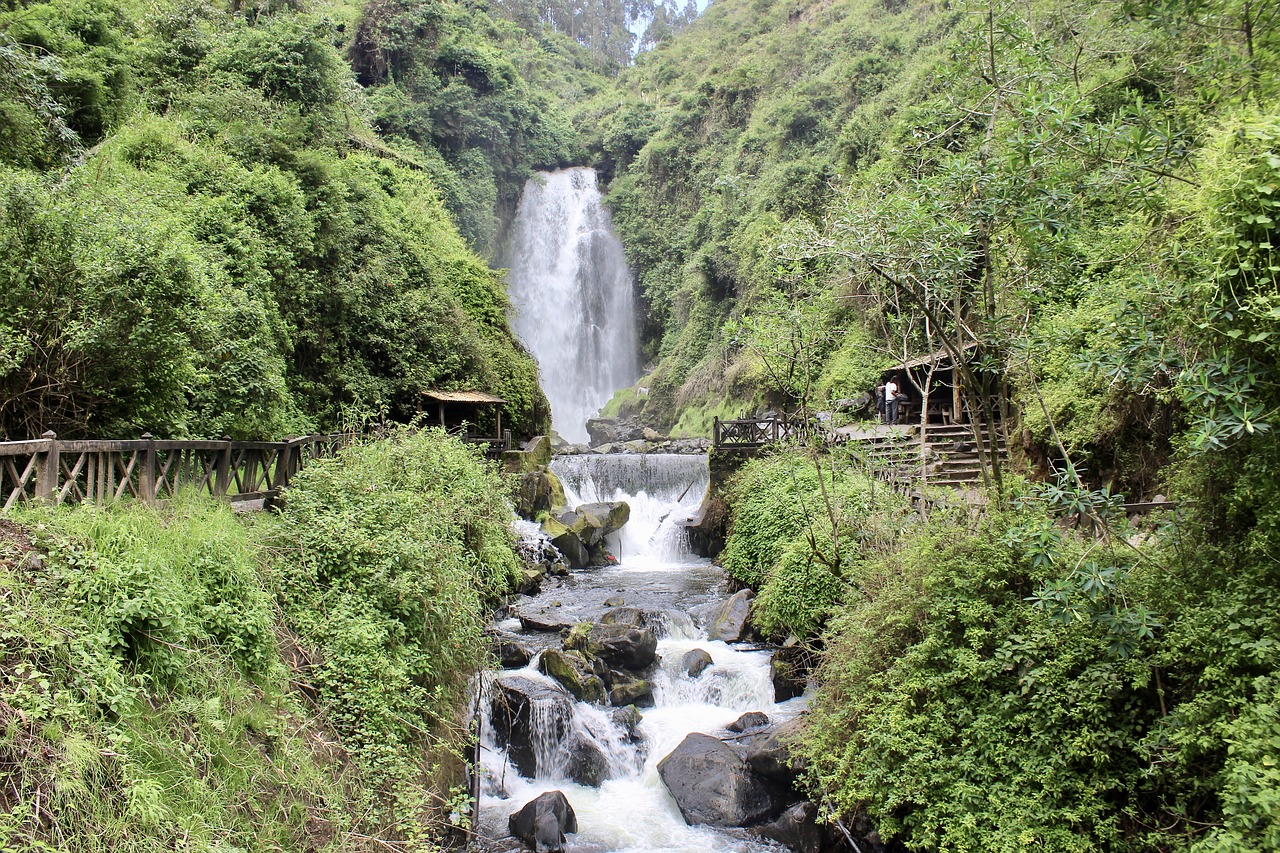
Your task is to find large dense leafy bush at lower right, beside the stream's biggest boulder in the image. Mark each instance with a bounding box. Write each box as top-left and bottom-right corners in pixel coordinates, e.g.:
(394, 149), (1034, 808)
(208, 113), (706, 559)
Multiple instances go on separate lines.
(804, 516), (1160, 850)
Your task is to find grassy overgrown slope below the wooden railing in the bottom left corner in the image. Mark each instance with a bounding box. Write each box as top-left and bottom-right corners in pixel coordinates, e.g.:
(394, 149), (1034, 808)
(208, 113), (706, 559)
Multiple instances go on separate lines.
(0, 502), (350, 853)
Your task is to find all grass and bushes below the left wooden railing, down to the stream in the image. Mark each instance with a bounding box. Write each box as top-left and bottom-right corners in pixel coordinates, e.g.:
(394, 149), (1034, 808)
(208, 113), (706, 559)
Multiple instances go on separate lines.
(0, 433), (515, 850)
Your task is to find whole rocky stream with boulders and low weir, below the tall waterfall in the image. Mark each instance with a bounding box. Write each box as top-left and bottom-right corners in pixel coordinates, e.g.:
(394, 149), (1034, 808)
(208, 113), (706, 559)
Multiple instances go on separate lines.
(479, 455), (849, 853)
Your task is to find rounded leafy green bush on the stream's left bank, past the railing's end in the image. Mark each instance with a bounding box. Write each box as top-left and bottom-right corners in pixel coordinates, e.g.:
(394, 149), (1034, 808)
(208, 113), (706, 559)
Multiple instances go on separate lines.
(259, 430), (517, 836)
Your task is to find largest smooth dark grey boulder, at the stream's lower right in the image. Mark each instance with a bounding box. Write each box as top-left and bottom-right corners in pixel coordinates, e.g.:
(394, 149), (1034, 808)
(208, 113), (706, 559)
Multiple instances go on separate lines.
(658, 733), (787, 826)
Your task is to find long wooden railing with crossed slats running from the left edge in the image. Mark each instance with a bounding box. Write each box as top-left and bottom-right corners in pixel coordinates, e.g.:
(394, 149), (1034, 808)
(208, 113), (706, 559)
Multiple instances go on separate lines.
(0, 432), (356, 511)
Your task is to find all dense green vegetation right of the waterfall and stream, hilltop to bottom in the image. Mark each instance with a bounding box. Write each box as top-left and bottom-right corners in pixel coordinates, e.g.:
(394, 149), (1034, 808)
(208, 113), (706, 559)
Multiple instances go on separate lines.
(624, 1), (1280, 850)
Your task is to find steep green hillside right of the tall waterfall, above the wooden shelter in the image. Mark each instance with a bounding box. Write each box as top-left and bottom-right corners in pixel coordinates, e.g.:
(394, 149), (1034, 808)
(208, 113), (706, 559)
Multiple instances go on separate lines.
(588, 0), (1276, 479)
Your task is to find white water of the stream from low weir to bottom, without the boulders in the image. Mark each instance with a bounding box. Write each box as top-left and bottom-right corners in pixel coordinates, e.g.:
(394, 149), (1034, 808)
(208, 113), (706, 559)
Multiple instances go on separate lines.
(480, 455), (804, 853)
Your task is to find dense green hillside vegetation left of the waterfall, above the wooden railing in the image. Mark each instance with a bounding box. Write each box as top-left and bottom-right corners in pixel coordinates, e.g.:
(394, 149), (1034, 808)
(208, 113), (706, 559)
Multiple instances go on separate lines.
(0, 0), (547, 438)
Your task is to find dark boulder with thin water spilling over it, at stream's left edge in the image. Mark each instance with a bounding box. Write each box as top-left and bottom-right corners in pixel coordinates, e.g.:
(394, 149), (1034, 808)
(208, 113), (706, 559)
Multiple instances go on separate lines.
(490, 675), (573, 779)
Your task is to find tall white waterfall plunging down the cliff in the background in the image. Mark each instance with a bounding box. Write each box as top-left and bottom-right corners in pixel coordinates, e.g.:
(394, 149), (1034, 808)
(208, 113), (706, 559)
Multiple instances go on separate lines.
(506, 168), (639, 442)
